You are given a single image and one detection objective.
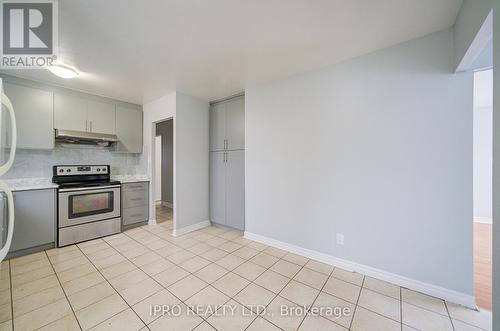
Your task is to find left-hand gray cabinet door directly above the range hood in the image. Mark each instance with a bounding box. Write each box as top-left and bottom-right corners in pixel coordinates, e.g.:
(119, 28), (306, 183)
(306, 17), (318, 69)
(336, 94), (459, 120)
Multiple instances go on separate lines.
(54, 93), (88, 131)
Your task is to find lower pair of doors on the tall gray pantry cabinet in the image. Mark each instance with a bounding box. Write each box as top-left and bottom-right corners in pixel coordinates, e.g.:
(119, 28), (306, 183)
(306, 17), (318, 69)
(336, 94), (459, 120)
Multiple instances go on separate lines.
(210, 150), (245, 231)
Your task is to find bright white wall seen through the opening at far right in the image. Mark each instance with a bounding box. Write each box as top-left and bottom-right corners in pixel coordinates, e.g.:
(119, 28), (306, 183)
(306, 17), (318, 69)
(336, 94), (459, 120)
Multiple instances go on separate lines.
(473, 70), (493, 222)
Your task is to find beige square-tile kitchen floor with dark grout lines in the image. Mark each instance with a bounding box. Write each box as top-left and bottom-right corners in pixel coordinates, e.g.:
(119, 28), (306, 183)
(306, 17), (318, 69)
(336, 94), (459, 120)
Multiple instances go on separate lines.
(0, 221), (491, 331)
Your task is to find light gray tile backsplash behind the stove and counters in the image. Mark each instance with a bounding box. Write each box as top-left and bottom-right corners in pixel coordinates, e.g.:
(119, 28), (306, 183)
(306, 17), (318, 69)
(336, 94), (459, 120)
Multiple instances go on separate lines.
(2, 144), (146, 179)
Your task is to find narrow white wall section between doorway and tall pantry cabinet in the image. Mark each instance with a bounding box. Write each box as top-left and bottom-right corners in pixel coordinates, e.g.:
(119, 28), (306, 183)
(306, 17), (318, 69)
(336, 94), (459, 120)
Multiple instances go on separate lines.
(174, 93), (209, 230)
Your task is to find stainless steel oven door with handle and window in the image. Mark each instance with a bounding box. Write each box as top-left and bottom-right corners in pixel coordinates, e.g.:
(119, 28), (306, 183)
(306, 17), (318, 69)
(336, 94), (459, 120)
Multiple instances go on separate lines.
(58, 185), (120, 228)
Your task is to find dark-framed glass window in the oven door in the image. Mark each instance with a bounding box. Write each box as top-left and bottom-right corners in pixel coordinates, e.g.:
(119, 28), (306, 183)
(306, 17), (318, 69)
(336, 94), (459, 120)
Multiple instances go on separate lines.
(68, 192), (114, 219)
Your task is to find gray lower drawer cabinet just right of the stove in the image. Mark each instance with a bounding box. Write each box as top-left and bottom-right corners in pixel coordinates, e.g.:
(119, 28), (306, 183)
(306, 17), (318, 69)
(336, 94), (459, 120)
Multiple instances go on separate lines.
(121, 182), (149, 229)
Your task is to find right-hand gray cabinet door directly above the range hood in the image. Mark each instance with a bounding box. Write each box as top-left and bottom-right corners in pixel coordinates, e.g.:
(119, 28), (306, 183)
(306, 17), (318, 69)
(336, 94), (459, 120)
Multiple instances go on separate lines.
(87, 100), (116, 134)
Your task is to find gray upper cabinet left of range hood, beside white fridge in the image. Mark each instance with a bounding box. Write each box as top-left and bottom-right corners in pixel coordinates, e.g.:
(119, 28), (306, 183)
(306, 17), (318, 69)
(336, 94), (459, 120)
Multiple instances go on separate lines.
(4, 83), (54, 149)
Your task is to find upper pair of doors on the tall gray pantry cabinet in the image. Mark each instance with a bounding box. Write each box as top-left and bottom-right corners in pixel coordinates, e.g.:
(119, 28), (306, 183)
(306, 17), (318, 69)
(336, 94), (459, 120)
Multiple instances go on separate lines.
(210, 96), (245, 152)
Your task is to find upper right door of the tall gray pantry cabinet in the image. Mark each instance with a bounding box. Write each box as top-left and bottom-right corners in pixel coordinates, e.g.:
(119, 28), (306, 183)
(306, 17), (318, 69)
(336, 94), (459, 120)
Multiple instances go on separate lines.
(226, 97), (245, 150)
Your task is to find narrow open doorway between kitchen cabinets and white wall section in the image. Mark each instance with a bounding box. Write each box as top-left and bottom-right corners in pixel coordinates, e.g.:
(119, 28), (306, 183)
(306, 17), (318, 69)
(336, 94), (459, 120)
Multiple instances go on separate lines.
(154, 119), (174, 227)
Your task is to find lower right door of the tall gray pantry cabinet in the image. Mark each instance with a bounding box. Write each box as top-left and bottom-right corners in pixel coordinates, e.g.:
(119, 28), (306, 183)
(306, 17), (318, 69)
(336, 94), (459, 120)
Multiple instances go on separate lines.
(226, 151), (245, 231)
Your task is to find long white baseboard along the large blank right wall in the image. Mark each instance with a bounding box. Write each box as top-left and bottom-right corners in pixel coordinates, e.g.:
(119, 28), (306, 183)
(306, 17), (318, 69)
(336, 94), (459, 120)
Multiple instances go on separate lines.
(245, 231), (476, 309)
